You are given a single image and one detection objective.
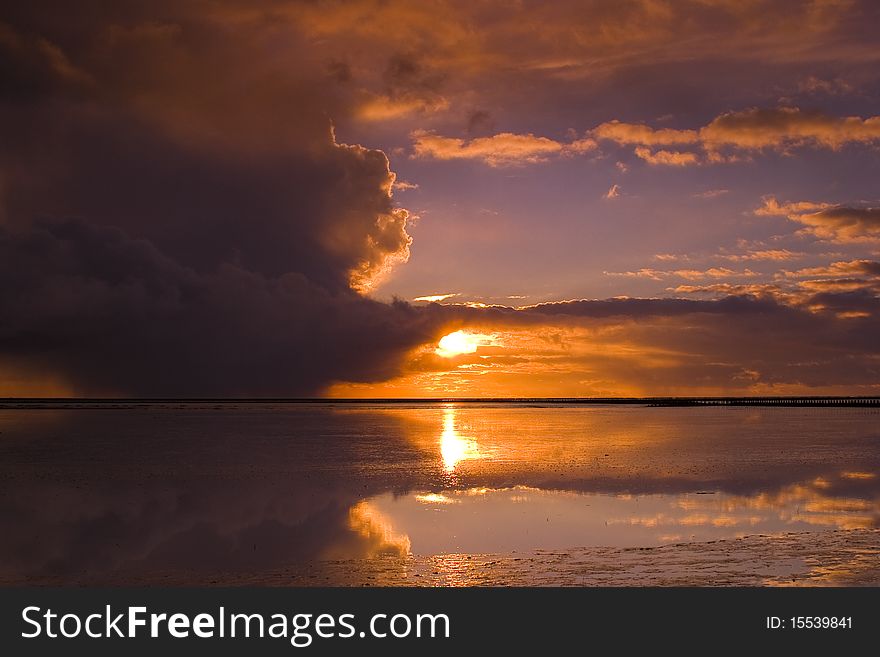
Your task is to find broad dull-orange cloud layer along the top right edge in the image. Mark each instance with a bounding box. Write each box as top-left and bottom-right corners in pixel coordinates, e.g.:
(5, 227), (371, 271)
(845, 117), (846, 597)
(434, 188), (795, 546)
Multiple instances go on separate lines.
(288, 0), (877, 88)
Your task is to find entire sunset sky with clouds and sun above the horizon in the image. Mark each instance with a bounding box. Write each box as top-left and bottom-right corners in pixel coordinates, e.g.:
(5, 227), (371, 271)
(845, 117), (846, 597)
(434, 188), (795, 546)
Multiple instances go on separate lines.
(0, 0), (880, 397)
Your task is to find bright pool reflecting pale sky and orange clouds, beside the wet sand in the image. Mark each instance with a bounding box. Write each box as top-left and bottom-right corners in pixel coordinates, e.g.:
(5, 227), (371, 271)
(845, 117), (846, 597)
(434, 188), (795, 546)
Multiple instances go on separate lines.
(358, 474), (880, 555)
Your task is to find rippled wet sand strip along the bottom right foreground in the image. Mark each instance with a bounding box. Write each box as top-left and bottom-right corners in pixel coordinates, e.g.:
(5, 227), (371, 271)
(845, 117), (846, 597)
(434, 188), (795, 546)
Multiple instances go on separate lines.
(292, 530), (880, 586)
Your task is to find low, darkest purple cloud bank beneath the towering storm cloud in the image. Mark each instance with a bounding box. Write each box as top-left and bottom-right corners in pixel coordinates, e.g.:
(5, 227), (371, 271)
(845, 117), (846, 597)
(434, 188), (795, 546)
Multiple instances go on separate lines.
(0, 220), (431, 395)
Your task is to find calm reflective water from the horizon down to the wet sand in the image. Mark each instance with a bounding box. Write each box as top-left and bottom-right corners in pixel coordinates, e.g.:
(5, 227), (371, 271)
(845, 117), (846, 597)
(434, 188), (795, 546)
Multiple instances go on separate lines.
(0, 403), (880, 583)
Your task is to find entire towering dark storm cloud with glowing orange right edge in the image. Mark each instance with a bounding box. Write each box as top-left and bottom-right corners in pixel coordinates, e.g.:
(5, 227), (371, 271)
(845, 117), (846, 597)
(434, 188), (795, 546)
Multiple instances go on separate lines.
(0, 4), (433, 395)
